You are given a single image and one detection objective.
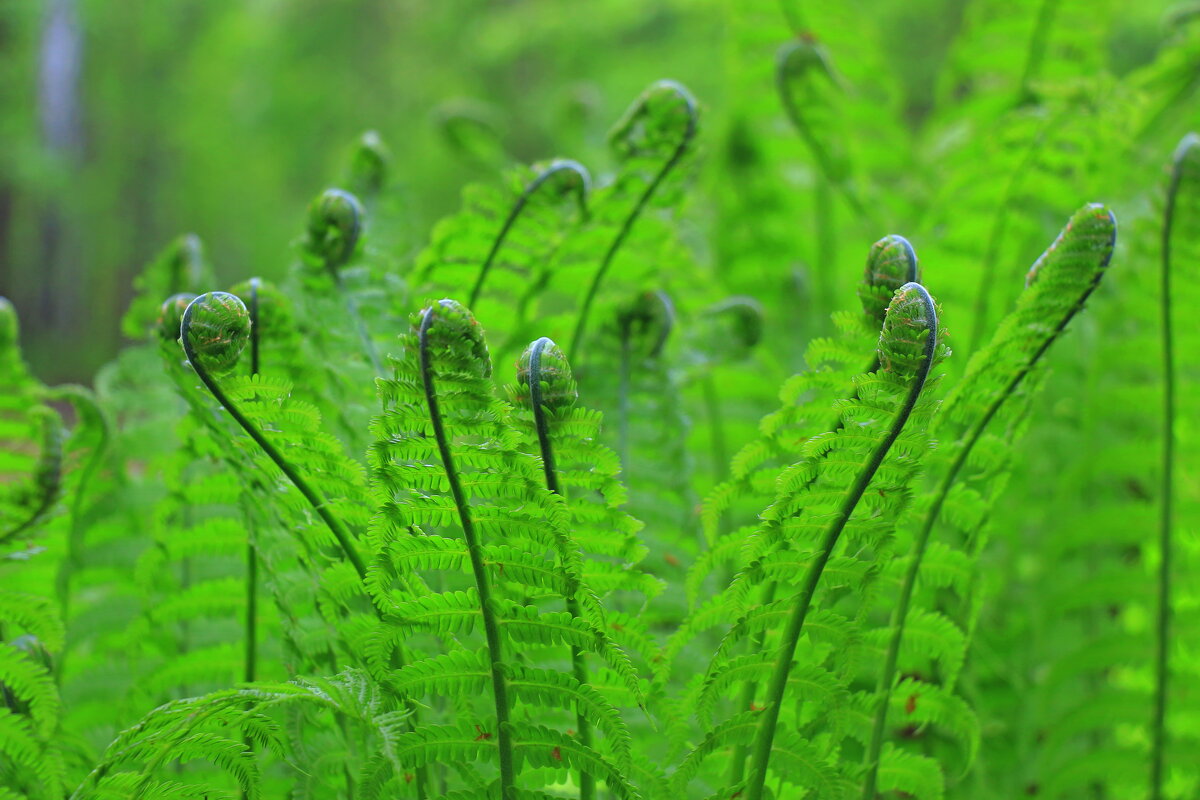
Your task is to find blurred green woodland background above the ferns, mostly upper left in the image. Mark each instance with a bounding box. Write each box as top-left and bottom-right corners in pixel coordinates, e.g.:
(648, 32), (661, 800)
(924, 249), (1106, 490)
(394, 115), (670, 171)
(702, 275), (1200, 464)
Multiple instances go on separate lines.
(0, 0), (1166, 381)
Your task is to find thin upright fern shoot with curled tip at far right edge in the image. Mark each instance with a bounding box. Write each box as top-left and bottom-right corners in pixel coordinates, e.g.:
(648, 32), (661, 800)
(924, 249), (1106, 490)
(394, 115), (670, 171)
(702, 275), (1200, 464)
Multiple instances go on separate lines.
(1150, 133), (1200, 800)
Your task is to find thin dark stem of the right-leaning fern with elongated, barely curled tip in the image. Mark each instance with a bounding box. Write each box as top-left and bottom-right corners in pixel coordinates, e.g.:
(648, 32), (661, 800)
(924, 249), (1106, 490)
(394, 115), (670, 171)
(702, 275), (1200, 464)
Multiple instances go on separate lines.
(863, 235), (1103, 800)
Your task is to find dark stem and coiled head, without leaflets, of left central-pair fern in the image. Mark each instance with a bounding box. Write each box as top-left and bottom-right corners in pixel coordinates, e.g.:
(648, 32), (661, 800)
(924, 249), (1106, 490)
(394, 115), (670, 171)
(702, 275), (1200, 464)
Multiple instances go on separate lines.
(418, 300), (516, 800)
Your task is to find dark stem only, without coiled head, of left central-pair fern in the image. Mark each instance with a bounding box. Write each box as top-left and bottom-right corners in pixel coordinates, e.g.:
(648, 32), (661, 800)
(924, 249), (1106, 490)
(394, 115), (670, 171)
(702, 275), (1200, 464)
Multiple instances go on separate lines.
(418, 305), (516, 800)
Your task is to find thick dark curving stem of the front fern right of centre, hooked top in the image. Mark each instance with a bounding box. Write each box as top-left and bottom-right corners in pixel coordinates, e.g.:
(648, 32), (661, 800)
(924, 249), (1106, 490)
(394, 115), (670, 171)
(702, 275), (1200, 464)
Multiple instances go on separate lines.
(746, 283), (937, 800)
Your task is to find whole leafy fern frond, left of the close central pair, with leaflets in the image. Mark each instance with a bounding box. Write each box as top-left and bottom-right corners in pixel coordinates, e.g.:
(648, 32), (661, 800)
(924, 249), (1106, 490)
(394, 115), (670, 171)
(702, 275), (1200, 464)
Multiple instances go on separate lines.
(367, 300), (640, 796)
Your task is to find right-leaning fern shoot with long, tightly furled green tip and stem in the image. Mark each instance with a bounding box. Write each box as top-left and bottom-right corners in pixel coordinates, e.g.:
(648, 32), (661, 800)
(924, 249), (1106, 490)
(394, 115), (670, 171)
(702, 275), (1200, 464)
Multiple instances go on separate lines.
(862, 204), (1116, 800)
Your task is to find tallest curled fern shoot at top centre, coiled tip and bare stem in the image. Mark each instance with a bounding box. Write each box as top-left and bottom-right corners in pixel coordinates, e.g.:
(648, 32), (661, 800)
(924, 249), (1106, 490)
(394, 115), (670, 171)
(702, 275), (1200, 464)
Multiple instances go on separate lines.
(566, 80), (698, 362)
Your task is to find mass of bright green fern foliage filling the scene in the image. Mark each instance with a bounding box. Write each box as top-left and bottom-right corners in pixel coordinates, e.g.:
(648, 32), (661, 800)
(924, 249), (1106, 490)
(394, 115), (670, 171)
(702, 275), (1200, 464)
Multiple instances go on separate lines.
(0, 0), (1200, 800)
